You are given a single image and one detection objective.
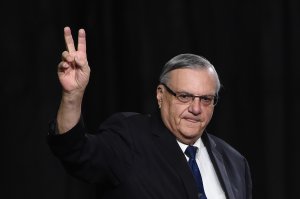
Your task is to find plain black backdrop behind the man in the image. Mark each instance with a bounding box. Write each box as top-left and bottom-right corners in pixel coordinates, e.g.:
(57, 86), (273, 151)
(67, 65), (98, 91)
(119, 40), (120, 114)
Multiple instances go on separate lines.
(0, 0), (300, 199)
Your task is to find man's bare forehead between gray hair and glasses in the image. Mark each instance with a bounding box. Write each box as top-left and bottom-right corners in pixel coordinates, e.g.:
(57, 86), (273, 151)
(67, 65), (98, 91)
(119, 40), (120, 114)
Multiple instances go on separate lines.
(169, 68), (217, 94)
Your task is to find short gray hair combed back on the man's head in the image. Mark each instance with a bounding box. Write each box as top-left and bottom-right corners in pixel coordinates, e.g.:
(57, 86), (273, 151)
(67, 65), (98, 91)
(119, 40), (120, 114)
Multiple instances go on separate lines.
(159, 54), (221, 94)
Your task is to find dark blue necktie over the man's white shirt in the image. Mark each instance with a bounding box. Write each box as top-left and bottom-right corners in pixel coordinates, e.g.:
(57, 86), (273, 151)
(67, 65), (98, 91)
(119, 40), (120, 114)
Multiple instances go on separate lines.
(185, 146), (207, 199)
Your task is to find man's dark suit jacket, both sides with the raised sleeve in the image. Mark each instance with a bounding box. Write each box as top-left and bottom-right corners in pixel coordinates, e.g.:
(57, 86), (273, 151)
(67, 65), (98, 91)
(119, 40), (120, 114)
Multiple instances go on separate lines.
(48, 113), (252, 199)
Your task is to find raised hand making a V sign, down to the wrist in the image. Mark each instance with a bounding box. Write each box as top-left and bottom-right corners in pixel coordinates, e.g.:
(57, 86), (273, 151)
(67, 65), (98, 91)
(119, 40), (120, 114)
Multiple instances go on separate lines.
(57, 27), (90, 94)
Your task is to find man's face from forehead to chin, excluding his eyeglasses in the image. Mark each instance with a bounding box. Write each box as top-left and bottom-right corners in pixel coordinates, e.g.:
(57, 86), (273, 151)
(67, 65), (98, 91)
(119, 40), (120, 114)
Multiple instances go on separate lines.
(157, 68), (217, 144)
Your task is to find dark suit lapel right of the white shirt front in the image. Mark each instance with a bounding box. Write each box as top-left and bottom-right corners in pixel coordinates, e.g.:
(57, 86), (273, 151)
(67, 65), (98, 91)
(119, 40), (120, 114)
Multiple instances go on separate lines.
(202, 133), (235, 199)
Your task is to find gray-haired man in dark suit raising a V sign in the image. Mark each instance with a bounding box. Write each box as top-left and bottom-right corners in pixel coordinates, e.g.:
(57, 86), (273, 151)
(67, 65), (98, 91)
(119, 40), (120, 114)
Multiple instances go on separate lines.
(48, 27), (252, 199)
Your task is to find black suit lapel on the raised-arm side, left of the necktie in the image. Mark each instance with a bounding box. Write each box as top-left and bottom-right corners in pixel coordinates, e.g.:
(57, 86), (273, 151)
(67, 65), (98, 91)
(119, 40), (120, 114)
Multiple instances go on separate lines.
(152, 115), (198, 199)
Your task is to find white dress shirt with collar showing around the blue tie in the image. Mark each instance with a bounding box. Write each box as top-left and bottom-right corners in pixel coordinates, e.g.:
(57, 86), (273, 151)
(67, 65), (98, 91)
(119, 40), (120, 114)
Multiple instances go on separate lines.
(177, 138), (226, 199)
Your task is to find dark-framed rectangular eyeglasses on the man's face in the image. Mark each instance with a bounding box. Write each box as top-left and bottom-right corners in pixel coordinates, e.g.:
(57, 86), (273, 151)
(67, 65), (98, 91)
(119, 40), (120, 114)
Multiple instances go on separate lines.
(161, 83), (218, 106)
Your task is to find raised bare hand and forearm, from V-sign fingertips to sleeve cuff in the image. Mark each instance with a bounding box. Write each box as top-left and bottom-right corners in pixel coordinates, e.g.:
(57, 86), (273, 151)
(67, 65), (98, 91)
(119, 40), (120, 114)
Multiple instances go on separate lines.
(56, 27), (90, 134)
